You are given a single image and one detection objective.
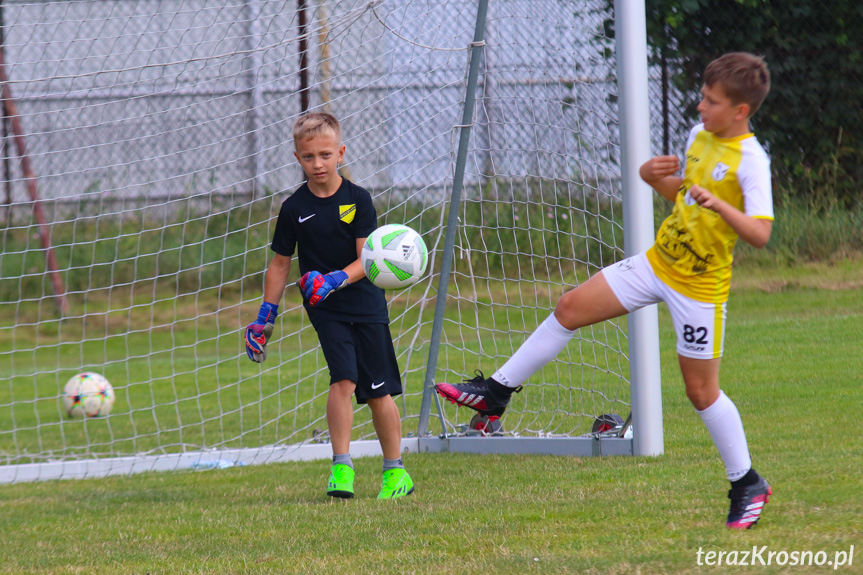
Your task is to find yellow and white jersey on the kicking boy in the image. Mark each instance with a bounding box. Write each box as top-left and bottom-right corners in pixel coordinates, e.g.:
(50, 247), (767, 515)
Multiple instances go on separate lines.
(647, 124), (773, 303)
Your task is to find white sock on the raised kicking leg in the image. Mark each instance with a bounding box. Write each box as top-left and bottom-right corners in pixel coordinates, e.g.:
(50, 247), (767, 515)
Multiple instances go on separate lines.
(492, 314), (575, 387)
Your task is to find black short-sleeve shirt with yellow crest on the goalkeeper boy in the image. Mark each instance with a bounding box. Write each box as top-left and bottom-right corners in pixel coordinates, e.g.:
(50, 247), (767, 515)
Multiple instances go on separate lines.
(271, 178), (389, 324)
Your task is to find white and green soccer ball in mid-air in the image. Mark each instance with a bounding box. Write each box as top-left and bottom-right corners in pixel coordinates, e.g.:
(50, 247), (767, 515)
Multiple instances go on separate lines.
(360, 224), (428, 289)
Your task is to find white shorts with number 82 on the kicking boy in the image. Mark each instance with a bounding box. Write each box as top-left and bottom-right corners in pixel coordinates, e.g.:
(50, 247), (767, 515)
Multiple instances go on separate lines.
(602, 253), (726, 359)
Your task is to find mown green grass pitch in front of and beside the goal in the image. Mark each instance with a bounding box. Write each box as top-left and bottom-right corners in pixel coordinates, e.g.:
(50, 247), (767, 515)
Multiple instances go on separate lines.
(0, 261), (863, 575)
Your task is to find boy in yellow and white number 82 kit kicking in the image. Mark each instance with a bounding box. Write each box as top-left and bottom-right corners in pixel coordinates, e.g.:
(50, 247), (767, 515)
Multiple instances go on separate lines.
(435, 52), (773, 529)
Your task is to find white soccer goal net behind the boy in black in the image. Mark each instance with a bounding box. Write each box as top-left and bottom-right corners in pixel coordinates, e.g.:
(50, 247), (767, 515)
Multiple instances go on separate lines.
(0, 0), (660, 481)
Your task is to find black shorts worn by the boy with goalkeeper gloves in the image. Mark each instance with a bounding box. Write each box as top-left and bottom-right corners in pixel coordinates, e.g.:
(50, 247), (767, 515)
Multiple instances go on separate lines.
(315, 321), (402, 403)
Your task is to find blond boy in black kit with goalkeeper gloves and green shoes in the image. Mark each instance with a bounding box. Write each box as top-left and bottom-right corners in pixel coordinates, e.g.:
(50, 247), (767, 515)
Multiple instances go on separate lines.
(245, 113), (414, 499)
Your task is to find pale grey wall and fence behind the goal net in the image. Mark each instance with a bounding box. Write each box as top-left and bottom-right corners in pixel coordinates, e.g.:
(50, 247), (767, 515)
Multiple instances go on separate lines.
(0, 0), (696, 219)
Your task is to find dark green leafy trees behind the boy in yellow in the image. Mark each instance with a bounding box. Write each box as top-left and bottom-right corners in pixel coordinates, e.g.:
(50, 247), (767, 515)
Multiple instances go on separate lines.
(606, 0), (863, 206)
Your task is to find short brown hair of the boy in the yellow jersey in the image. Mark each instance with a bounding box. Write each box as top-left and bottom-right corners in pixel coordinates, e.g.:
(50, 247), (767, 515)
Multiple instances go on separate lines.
(704, 52), (770, 116)
